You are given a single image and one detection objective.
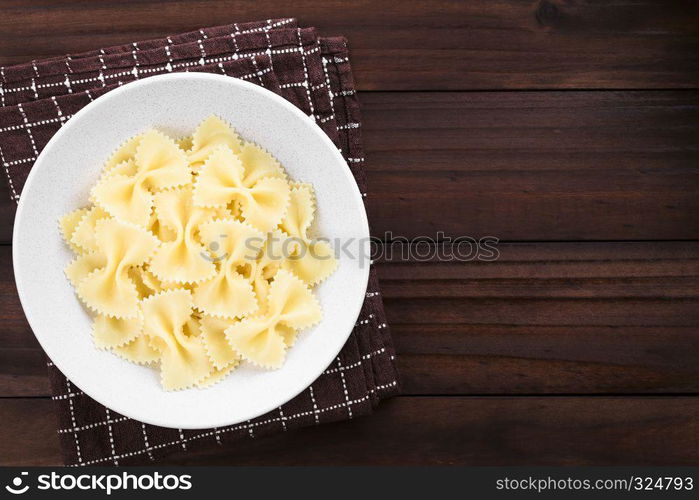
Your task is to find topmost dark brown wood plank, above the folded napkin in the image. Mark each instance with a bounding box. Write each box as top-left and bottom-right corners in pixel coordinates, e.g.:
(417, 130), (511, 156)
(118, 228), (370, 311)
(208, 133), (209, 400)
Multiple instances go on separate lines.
(0, 0), (699, 90)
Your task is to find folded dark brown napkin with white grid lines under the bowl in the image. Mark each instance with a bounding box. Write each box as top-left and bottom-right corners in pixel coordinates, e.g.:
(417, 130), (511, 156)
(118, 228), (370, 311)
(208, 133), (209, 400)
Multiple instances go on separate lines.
(0, 19), (398, 465)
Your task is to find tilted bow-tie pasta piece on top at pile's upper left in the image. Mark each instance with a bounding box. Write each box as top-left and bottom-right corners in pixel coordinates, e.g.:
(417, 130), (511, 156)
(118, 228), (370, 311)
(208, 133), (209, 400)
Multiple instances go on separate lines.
(91, 130), (192, 227)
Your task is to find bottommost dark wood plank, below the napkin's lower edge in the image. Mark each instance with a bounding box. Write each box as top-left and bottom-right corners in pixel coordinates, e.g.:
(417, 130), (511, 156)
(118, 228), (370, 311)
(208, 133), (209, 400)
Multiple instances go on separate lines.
(0, 397), (699, 466)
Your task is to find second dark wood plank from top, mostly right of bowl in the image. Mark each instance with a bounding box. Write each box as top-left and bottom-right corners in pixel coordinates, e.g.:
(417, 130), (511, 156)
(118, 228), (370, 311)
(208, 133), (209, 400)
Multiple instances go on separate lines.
(0, 91), (699, 242)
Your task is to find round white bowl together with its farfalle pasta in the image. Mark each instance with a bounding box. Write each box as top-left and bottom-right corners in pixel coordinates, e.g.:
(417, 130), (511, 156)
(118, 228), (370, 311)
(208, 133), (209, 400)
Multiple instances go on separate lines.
(14, 74), (368, 428)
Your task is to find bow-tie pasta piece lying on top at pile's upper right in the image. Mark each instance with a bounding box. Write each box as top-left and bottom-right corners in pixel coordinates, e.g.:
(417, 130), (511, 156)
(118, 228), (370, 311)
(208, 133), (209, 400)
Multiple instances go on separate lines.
(194, 148), (290, 232)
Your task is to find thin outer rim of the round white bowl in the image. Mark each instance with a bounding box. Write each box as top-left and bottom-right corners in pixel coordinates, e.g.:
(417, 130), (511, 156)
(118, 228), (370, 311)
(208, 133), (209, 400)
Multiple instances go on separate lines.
(12, 72), (371, 429)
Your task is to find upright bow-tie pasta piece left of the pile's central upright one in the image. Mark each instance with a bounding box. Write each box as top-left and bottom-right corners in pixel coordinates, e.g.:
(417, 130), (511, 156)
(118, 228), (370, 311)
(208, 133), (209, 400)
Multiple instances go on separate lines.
(76, 218), (160, 318)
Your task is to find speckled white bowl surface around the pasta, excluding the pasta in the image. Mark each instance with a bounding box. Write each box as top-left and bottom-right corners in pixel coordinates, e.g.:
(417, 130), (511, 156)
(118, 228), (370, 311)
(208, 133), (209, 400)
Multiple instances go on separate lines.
(13, 73), (369, 429)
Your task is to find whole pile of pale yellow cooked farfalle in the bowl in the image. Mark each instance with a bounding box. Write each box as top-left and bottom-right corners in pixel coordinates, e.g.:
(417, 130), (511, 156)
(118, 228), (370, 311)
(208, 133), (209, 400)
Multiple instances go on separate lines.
(60, 116), (337, 390)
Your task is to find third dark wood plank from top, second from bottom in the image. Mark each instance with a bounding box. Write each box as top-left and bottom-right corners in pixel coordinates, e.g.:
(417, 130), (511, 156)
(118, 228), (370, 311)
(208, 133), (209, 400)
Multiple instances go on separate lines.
(0, 242), (699, 396)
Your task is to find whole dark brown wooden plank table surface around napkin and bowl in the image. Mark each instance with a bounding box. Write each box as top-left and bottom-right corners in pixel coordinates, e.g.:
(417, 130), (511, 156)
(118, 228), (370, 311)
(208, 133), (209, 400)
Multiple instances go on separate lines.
(0, 0), (699, 465)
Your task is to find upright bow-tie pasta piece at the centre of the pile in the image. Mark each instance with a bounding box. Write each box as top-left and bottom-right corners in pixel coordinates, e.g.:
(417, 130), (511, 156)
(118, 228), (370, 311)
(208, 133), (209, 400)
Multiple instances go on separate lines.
(149, 187), (216, 283)
